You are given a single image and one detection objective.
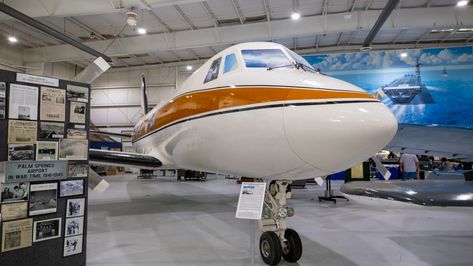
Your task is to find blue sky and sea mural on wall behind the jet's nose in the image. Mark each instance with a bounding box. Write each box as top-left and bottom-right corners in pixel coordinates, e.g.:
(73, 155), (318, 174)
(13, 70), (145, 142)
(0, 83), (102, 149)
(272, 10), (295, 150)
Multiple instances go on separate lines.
(304, 47), (473, 128)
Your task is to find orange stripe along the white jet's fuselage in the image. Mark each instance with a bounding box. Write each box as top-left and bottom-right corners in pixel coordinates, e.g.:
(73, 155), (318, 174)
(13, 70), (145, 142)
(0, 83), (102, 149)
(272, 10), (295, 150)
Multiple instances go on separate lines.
(133, 87), (374, 141)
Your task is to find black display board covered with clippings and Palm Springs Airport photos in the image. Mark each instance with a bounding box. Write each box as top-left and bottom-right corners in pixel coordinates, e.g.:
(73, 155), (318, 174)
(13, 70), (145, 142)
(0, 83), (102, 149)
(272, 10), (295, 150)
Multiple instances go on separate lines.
(0, 70), (90, 266)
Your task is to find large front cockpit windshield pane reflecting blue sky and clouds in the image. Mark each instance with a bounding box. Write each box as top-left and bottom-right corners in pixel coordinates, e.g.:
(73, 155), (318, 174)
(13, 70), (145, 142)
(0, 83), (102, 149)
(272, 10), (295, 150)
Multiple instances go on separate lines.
(241, 49), (294, 68)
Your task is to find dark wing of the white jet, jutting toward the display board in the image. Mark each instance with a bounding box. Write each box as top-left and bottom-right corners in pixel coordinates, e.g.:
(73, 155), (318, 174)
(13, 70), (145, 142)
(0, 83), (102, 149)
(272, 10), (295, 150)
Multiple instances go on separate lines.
(89, 149), (163, 169)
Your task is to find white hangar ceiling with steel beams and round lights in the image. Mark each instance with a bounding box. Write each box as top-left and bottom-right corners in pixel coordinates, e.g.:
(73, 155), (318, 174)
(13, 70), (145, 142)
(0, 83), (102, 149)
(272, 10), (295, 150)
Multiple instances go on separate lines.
(0, 0), (473, 68)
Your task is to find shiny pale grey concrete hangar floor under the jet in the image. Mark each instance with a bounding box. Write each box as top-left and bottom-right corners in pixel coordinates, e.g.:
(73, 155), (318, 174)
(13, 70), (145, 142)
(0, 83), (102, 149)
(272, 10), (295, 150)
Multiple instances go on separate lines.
(87, 175), (473, 266)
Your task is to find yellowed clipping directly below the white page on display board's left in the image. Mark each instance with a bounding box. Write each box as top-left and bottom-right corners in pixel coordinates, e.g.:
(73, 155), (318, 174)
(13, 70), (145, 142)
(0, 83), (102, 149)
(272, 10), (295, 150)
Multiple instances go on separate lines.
(8, 120), (38, 144)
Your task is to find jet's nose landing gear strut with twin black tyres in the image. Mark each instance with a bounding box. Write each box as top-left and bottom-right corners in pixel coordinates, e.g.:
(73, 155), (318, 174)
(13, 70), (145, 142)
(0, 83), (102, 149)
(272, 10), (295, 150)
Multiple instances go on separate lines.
(259, 181), (302, 265)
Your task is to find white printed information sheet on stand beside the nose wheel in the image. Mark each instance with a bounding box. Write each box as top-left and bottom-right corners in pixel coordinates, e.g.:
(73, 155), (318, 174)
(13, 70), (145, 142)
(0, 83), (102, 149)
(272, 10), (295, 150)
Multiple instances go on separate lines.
(235, 182), (266, 220)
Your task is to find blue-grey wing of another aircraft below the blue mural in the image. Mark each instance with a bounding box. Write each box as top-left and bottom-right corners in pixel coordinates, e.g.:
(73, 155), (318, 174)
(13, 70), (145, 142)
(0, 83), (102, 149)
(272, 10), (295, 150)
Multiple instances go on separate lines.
(384, 124), (473, 162)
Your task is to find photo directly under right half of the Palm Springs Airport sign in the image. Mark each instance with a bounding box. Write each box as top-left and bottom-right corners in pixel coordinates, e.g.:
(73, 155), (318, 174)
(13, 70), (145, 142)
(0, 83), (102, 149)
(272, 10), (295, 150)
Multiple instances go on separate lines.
(29, 183), (57, 215)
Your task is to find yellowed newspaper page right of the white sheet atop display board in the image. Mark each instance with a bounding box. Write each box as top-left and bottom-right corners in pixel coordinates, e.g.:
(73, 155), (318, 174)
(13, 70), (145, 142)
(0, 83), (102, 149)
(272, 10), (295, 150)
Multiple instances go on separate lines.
(40, 87), (66, 121)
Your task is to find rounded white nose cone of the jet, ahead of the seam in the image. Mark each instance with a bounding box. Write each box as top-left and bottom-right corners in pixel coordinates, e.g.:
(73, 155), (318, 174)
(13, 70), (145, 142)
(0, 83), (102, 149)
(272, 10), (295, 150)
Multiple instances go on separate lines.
(284, 102), (397, 173)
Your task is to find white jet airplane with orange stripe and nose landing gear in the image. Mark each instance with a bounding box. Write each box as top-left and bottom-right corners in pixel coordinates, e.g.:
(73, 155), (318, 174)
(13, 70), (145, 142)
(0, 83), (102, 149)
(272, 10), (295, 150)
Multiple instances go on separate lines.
(89, 42), (398, 265)
